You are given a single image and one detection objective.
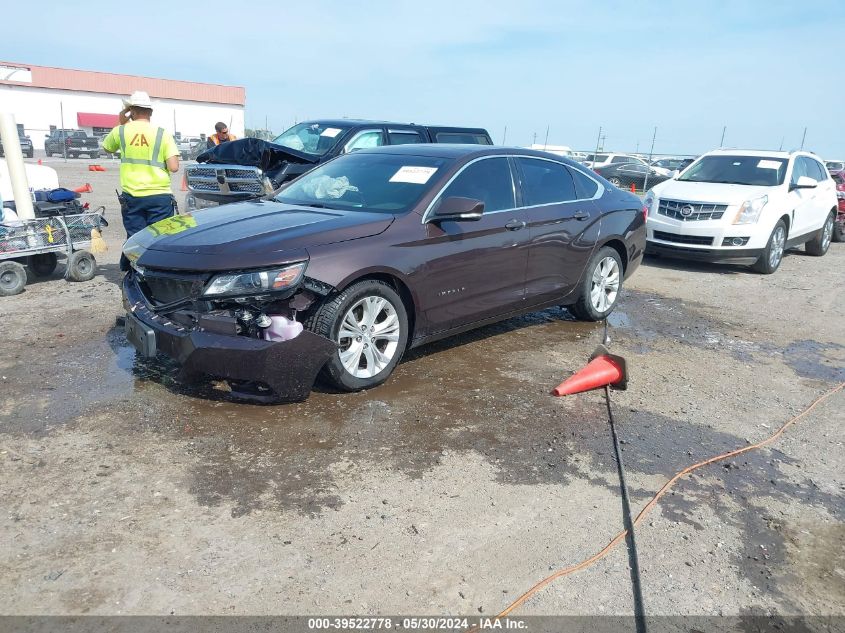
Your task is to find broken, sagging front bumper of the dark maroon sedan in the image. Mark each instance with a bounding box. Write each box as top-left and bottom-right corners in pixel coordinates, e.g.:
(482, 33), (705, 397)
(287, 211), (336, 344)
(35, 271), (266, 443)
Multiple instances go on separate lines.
(123, 273), (337, 401)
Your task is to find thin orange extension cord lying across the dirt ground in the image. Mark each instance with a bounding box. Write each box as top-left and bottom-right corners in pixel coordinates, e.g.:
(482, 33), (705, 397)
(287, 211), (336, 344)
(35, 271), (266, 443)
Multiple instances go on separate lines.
(496, 382), (845, 618)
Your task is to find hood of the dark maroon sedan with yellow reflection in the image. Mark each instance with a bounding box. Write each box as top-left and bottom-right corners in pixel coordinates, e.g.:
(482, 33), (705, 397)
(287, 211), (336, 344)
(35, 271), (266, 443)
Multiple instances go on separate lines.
(123, 201), (394, 270)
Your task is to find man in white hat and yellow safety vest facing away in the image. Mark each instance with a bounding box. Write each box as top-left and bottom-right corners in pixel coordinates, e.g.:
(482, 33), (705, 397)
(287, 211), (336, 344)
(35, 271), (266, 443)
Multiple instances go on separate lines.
(103, 90), (179, 270)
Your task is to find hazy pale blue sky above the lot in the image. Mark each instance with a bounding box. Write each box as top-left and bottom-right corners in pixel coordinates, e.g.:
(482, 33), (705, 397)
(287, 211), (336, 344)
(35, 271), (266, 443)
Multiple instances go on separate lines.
(6, 0), (845, 158)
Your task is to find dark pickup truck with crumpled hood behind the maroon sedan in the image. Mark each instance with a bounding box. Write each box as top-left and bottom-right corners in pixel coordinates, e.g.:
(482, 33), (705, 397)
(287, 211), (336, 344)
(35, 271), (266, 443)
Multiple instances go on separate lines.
(185, 119), (493, 206)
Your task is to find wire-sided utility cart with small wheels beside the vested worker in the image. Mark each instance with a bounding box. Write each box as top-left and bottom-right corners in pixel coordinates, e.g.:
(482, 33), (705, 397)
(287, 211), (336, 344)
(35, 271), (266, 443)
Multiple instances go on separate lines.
(0, 207), (108, 296)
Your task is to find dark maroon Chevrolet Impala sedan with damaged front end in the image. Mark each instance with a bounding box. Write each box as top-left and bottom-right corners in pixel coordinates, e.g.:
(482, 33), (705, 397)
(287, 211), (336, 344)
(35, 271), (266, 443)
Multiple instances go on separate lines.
(123, 144), (646, 400)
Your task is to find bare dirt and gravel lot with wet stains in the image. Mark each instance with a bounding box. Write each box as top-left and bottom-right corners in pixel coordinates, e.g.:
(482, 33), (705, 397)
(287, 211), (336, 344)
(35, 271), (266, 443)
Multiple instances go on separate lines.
(0, 159), (845, 615)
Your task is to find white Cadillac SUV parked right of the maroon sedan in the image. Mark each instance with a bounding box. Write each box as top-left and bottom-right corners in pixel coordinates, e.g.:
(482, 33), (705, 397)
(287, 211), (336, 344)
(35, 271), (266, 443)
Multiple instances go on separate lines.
(644, 149), (836, 274)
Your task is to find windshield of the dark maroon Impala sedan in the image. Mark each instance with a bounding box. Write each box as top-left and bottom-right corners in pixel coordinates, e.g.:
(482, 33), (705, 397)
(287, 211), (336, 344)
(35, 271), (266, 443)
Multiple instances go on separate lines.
(275, 152), (450, 213)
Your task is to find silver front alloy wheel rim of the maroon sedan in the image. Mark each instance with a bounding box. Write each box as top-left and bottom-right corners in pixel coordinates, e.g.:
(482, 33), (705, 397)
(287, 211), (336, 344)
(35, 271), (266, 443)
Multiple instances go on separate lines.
(337, 295), (400, 378)
